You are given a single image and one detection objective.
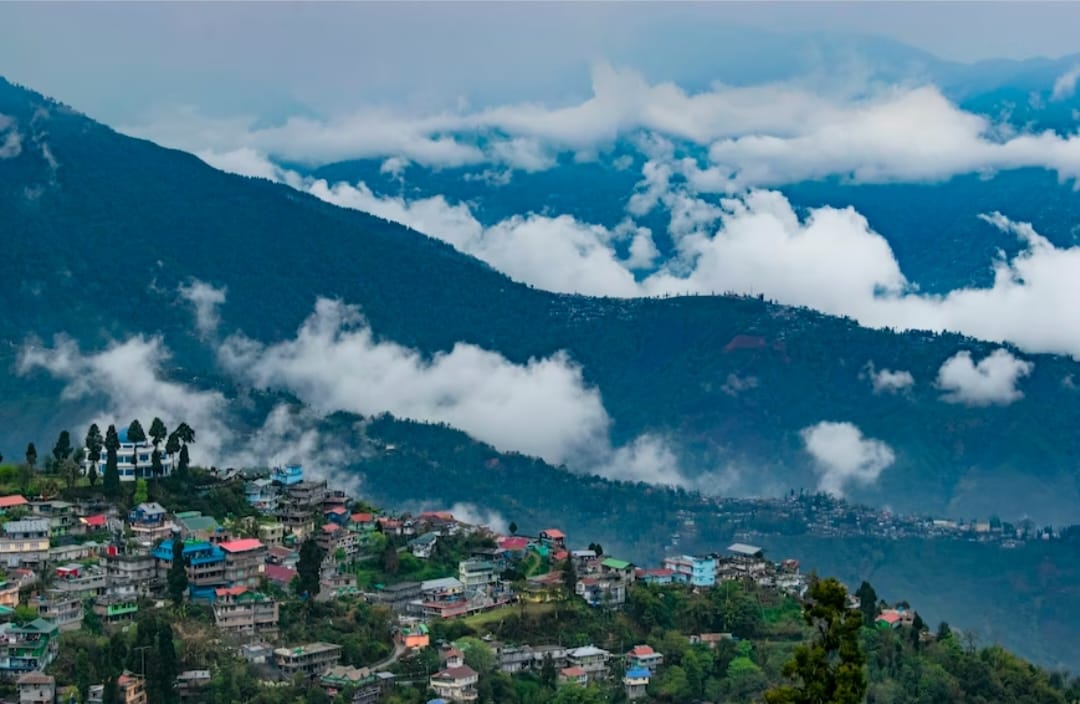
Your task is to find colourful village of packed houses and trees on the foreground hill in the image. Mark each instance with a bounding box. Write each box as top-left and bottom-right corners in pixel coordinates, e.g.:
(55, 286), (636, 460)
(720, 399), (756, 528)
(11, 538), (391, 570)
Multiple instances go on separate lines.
(0, 419), (1071, 704)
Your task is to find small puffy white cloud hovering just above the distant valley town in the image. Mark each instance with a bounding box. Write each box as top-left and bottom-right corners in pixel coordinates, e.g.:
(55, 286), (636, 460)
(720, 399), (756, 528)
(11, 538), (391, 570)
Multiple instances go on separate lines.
(799, 421), (896, 497)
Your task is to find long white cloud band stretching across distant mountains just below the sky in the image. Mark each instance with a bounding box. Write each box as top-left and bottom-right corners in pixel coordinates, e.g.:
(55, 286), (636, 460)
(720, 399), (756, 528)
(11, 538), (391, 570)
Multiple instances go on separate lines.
(124, 63), (1080, 186)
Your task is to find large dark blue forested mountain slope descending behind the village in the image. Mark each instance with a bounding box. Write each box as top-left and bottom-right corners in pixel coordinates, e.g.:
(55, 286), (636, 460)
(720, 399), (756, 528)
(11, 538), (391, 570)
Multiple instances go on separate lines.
(0, 75), (1080, 523)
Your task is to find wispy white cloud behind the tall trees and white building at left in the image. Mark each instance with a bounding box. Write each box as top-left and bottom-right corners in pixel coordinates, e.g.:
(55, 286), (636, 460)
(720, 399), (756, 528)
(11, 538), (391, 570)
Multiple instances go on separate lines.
(16, 336), (229, 462)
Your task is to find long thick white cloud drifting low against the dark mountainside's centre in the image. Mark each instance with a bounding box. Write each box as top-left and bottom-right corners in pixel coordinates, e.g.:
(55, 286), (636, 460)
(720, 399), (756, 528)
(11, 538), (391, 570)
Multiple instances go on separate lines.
(219, 299), (610, 464)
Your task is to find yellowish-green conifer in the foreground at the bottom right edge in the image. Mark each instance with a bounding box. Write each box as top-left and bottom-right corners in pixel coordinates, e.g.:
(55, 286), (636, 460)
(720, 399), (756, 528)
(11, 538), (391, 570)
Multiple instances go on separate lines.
(765, 578), (866, 704)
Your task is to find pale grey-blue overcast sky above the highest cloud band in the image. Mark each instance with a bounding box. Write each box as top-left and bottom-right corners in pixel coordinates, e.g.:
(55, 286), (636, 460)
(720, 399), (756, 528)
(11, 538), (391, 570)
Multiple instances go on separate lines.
(0, 2), (1080, 123)
